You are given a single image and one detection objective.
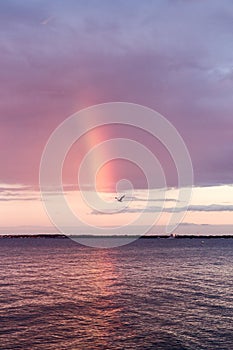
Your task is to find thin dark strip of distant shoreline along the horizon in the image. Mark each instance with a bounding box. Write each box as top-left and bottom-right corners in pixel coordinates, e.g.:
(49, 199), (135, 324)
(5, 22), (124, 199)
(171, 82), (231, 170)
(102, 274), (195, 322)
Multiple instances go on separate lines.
(0, 234), (233, 239)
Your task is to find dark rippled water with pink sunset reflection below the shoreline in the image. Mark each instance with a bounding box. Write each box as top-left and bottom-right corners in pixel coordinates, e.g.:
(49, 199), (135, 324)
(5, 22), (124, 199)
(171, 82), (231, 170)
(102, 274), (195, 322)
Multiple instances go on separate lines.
(0, 238), (233, 350)
